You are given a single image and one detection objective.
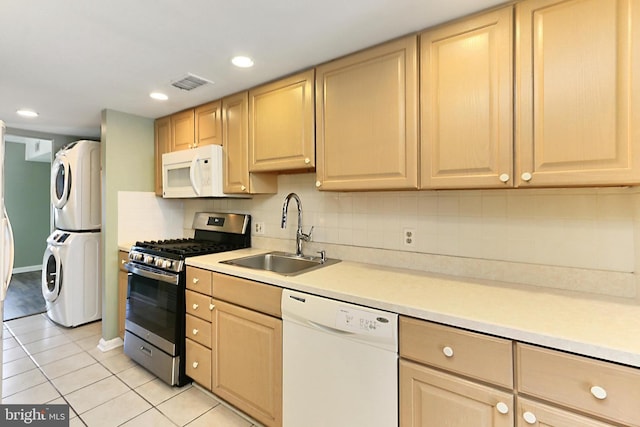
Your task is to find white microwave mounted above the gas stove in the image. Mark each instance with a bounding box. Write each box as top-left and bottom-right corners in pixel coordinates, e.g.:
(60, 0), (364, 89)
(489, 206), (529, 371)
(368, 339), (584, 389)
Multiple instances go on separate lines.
(162, 145), (227, 198)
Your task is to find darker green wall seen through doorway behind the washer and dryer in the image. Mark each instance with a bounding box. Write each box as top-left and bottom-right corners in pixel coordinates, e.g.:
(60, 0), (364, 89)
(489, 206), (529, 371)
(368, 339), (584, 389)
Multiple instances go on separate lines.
(5, 142), (51, 268)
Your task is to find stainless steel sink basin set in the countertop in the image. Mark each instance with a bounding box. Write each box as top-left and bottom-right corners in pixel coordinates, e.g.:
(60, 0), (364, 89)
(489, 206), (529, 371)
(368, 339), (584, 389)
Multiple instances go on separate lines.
(220, 252), (340, 276)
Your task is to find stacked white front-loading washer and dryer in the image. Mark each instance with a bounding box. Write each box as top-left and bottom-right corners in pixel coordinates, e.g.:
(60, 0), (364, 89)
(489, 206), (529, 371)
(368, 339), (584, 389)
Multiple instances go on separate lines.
(42, 140), (102, 327)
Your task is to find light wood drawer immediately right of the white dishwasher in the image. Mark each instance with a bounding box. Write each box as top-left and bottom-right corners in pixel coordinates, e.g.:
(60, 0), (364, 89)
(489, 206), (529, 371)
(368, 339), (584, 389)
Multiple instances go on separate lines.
(400, 316), (513, 388)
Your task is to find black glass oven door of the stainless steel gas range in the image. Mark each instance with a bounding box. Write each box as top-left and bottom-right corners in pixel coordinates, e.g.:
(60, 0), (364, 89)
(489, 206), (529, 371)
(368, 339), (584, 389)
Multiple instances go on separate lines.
(125, 263), (184, 356)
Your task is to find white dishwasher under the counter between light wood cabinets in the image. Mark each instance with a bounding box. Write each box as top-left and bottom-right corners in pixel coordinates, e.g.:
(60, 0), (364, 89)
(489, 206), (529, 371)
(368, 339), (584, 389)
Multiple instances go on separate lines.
(282, 289), (398, 427)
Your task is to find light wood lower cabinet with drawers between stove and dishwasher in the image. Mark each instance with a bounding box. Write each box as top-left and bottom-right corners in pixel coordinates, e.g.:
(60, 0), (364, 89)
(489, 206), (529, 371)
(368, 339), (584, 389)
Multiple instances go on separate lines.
(185, 267), (282, 427)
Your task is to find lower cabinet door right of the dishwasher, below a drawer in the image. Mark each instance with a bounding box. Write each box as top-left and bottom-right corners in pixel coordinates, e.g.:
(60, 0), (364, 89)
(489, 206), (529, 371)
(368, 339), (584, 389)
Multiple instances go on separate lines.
(400, 360), (514, 427)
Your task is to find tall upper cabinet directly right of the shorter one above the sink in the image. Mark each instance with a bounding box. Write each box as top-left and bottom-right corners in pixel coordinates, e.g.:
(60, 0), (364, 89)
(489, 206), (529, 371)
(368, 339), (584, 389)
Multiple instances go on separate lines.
(316, 36), (418, 190)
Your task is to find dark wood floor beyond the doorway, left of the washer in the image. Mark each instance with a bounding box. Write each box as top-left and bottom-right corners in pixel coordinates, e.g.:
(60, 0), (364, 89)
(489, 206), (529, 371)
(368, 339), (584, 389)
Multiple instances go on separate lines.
(4, 271), (47, 321)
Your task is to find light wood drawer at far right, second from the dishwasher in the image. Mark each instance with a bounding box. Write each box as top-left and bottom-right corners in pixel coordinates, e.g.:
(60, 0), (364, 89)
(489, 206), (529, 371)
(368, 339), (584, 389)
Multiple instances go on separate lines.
(516, 344), (640, 426)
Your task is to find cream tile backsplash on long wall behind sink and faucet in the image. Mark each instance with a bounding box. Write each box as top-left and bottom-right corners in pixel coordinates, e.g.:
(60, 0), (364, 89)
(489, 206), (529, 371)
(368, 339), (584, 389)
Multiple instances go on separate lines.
(119, 173), (640, 297)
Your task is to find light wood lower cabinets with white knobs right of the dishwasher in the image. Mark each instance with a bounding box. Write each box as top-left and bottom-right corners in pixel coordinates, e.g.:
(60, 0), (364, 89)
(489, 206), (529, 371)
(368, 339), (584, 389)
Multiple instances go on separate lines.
(399, 316), (640, 427)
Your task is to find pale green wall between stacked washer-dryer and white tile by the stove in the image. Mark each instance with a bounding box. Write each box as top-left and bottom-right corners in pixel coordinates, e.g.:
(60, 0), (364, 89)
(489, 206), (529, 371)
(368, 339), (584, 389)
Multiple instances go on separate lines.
(100, 110), (155, 341)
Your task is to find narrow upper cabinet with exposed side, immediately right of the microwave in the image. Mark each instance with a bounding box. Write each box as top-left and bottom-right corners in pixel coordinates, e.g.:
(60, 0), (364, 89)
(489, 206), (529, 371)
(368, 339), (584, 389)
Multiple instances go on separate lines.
(222, 92), (277, 194)
